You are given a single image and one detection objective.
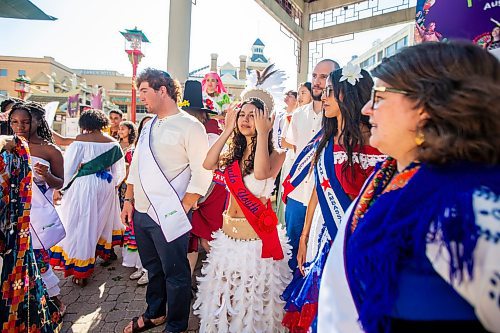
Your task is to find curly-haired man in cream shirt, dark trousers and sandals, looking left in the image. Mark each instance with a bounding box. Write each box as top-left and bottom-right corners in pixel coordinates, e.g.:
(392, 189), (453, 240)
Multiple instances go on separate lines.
(122, 68), (212, 333)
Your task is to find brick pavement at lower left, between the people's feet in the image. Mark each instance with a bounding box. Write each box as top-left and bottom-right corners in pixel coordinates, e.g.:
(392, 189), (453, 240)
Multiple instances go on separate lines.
(56, 248), (199, 333)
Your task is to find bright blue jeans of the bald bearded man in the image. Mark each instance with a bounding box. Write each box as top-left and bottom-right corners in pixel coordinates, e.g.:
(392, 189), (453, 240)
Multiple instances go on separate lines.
(285, 198), (307, 272)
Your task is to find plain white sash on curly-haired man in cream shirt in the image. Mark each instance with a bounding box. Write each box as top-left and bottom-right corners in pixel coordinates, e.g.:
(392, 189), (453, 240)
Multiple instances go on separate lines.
(136, 117), (191, 242)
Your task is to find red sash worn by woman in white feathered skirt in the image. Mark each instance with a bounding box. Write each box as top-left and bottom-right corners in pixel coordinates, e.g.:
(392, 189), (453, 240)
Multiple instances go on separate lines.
(224, 161), (284, 260)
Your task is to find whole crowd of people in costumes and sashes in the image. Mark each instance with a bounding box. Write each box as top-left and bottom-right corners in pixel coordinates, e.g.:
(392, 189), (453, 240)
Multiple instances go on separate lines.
(0, 42), (500, 333)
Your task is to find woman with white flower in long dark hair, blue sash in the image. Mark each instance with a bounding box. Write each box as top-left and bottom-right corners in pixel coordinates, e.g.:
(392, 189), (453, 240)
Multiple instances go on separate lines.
(283, 64), (385, 332)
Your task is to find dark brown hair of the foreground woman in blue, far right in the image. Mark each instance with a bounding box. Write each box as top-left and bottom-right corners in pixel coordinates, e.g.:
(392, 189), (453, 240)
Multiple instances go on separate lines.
(372, 41), (500, 164)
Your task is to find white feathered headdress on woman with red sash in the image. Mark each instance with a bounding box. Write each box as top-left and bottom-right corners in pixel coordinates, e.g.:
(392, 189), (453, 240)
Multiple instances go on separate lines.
(241, 64), (286, 112)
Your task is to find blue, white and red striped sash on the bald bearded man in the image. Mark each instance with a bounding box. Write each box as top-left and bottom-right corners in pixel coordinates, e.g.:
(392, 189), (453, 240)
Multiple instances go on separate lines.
(281, 129), (323, 204)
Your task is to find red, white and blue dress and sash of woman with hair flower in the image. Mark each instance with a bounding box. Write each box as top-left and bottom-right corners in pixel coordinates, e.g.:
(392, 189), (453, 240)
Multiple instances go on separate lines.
(283, 138), (385, 332)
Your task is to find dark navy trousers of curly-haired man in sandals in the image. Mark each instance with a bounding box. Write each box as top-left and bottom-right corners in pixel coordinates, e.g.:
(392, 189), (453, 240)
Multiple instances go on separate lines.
(134, 211), (191, 332)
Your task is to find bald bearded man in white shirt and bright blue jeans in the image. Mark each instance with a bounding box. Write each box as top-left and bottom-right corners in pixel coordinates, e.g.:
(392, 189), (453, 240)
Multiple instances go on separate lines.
(282, 59), (339, 270)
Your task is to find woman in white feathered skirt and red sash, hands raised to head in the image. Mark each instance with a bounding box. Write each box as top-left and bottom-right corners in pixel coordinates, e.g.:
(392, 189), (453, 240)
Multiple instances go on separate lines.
(194, 96), (291, 332)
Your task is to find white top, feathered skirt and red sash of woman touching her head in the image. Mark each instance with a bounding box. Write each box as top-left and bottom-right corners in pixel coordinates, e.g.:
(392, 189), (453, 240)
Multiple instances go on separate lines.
(194, 161), (291, 333)
